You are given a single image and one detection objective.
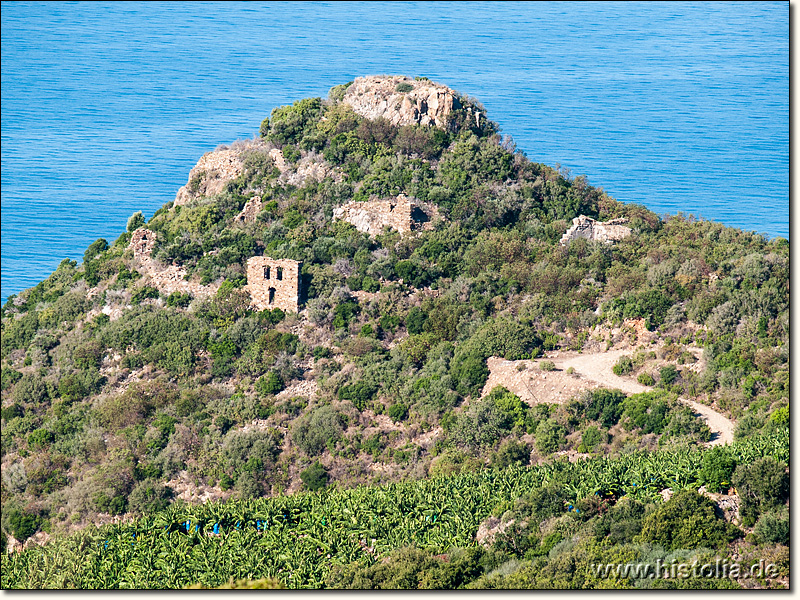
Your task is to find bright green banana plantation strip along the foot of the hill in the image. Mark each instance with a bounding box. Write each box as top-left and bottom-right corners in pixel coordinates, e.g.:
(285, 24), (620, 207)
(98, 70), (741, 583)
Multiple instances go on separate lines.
(2, 430), (789, 589)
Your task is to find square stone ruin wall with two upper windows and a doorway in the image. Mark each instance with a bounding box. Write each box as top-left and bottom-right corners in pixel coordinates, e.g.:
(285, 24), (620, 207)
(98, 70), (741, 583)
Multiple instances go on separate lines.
(245, 256), (303, 312)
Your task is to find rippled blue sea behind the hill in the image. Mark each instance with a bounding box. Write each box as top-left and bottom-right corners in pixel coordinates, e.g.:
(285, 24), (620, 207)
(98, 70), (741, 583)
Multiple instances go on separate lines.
(0, 2), (789, 302)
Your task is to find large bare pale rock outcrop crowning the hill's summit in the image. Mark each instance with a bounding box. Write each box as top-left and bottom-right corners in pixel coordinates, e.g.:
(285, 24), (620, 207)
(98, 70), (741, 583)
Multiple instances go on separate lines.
(342, 75), (478, 128)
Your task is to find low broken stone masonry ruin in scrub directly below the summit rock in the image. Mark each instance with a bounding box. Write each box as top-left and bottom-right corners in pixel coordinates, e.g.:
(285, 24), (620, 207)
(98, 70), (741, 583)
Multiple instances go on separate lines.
(333, 194), (429, 236)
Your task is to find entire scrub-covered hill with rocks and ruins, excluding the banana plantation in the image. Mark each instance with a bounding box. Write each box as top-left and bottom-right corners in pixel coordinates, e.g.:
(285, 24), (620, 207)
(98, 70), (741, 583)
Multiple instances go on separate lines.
(2, 76), (789, 587)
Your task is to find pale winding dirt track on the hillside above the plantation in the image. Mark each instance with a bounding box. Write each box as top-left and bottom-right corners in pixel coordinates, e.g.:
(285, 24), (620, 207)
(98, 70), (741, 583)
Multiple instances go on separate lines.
(552, 350), (734, 446)
